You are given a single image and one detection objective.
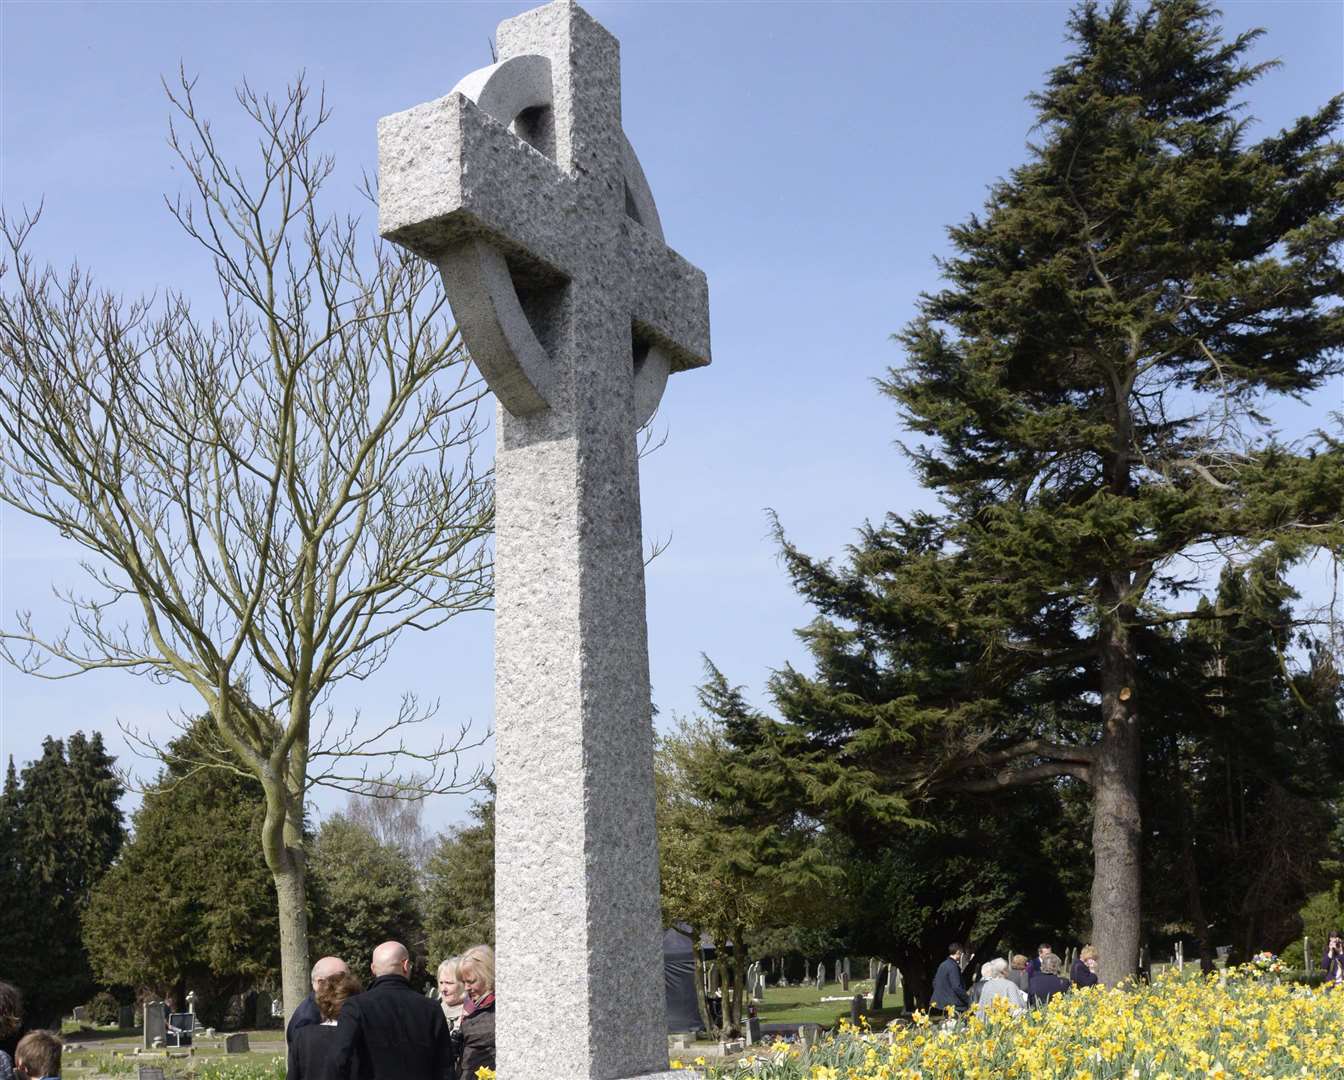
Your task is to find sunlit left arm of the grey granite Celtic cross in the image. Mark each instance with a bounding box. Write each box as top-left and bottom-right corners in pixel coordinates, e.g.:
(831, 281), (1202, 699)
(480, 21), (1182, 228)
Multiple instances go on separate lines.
(378, 93), (575, 277)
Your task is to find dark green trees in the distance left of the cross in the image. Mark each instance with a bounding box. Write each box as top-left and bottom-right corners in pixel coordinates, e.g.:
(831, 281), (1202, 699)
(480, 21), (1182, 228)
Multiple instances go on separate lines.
(0, 721), (493, 1026)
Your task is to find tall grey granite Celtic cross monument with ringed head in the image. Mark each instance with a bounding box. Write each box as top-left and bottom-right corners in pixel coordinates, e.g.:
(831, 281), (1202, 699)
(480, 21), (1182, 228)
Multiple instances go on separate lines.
(378, 0), (710, 1080)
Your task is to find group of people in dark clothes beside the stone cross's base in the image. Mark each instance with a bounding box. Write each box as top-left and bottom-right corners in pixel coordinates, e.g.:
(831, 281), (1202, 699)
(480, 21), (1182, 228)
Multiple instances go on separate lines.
(285, 942), (495, 1080)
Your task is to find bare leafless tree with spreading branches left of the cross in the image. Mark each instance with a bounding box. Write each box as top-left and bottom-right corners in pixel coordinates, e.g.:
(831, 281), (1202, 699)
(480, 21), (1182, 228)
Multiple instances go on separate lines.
(0, 75), (493, 1009)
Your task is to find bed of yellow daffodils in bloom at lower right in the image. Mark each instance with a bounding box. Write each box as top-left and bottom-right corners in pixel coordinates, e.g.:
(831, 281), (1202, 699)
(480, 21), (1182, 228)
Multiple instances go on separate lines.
(672, 967), (1344, 1080)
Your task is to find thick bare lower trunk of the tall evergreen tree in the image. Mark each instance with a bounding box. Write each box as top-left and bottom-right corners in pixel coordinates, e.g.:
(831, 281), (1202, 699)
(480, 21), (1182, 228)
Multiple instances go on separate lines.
(1091, 574), (1141, 986)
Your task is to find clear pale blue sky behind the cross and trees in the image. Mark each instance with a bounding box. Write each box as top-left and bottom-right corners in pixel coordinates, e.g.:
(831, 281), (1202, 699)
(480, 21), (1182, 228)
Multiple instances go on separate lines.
(0, 0), (1344, 827)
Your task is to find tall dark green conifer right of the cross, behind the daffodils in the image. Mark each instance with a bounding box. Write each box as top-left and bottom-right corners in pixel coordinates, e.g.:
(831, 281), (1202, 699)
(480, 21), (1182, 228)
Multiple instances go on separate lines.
(774, 0), (1344, 983)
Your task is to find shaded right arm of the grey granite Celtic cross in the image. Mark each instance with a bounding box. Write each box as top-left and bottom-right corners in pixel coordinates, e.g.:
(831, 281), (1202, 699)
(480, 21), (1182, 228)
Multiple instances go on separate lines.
(621, 219), (710, 371)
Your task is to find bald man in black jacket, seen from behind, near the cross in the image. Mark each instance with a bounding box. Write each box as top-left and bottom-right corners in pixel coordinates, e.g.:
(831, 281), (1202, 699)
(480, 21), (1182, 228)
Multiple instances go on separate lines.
(332, 942), (457, 1080)
